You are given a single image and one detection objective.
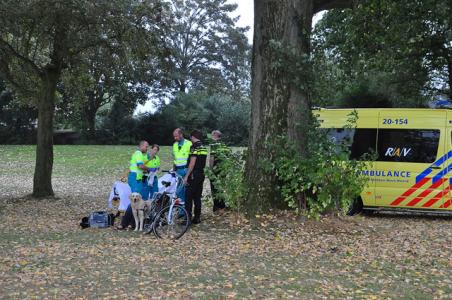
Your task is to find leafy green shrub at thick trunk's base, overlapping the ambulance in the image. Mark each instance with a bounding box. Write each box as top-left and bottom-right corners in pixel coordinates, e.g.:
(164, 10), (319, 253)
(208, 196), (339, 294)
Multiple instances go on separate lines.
(266, 110), (369, 218)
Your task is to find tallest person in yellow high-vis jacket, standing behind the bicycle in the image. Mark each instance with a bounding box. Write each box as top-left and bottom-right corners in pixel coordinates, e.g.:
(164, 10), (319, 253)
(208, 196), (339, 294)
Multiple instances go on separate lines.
(173, 128), (192, 202)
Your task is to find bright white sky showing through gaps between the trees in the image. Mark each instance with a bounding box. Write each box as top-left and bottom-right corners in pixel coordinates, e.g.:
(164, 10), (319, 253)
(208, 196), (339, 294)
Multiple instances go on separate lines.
(135, 0), (324, 114)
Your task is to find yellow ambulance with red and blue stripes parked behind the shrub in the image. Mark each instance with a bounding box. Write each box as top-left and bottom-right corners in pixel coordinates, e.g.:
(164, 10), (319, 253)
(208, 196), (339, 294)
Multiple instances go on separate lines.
(314, 108), (452, 213)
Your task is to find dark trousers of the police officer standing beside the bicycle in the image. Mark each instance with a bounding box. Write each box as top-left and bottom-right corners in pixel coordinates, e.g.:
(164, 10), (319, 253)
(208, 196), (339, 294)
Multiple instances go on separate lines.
(185, 171), (205, 220)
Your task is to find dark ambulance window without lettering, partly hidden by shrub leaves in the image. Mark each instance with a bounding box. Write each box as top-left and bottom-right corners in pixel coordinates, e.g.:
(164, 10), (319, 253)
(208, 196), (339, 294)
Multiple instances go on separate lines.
(328, 128), (377, 159)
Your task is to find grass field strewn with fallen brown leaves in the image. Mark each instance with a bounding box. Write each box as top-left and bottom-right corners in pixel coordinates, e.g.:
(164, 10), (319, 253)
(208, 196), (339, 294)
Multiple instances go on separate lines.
(0, 146), (452, 299)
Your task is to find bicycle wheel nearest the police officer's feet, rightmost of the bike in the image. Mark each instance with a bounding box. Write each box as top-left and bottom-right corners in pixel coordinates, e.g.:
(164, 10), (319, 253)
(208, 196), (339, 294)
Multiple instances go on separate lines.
(153, 205), (189, 240)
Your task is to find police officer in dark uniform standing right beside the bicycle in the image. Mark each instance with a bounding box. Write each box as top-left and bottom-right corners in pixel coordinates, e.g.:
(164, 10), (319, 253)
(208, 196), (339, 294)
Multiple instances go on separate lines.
(184, 130), (207, 224)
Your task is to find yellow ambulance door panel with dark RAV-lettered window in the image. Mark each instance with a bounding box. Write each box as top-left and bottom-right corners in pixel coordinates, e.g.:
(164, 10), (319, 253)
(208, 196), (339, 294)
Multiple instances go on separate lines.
(373, 109), (448, 209)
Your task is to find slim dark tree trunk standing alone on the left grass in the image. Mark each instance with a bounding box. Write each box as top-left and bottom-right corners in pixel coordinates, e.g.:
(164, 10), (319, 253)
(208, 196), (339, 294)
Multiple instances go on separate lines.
(33, 70), (59, 198)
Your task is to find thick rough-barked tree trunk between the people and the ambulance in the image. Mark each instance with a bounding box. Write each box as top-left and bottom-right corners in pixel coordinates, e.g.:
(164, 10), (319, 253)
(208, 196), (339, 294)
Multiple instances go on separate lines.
(245, 0), (352, 215)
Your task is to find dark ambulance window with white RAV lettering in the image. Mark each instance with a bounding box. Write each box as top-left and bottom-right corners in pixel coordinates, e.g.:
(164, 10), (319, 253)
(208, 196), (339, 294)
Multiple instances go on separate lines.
(378, 129), (439, 163)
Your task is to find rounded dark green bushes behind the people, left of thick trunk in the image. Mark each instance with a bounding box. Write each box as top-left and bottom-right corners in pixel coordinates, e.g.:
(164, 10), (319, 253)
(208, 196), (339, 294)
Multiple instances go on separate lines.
(132, 92), (251, 146)
